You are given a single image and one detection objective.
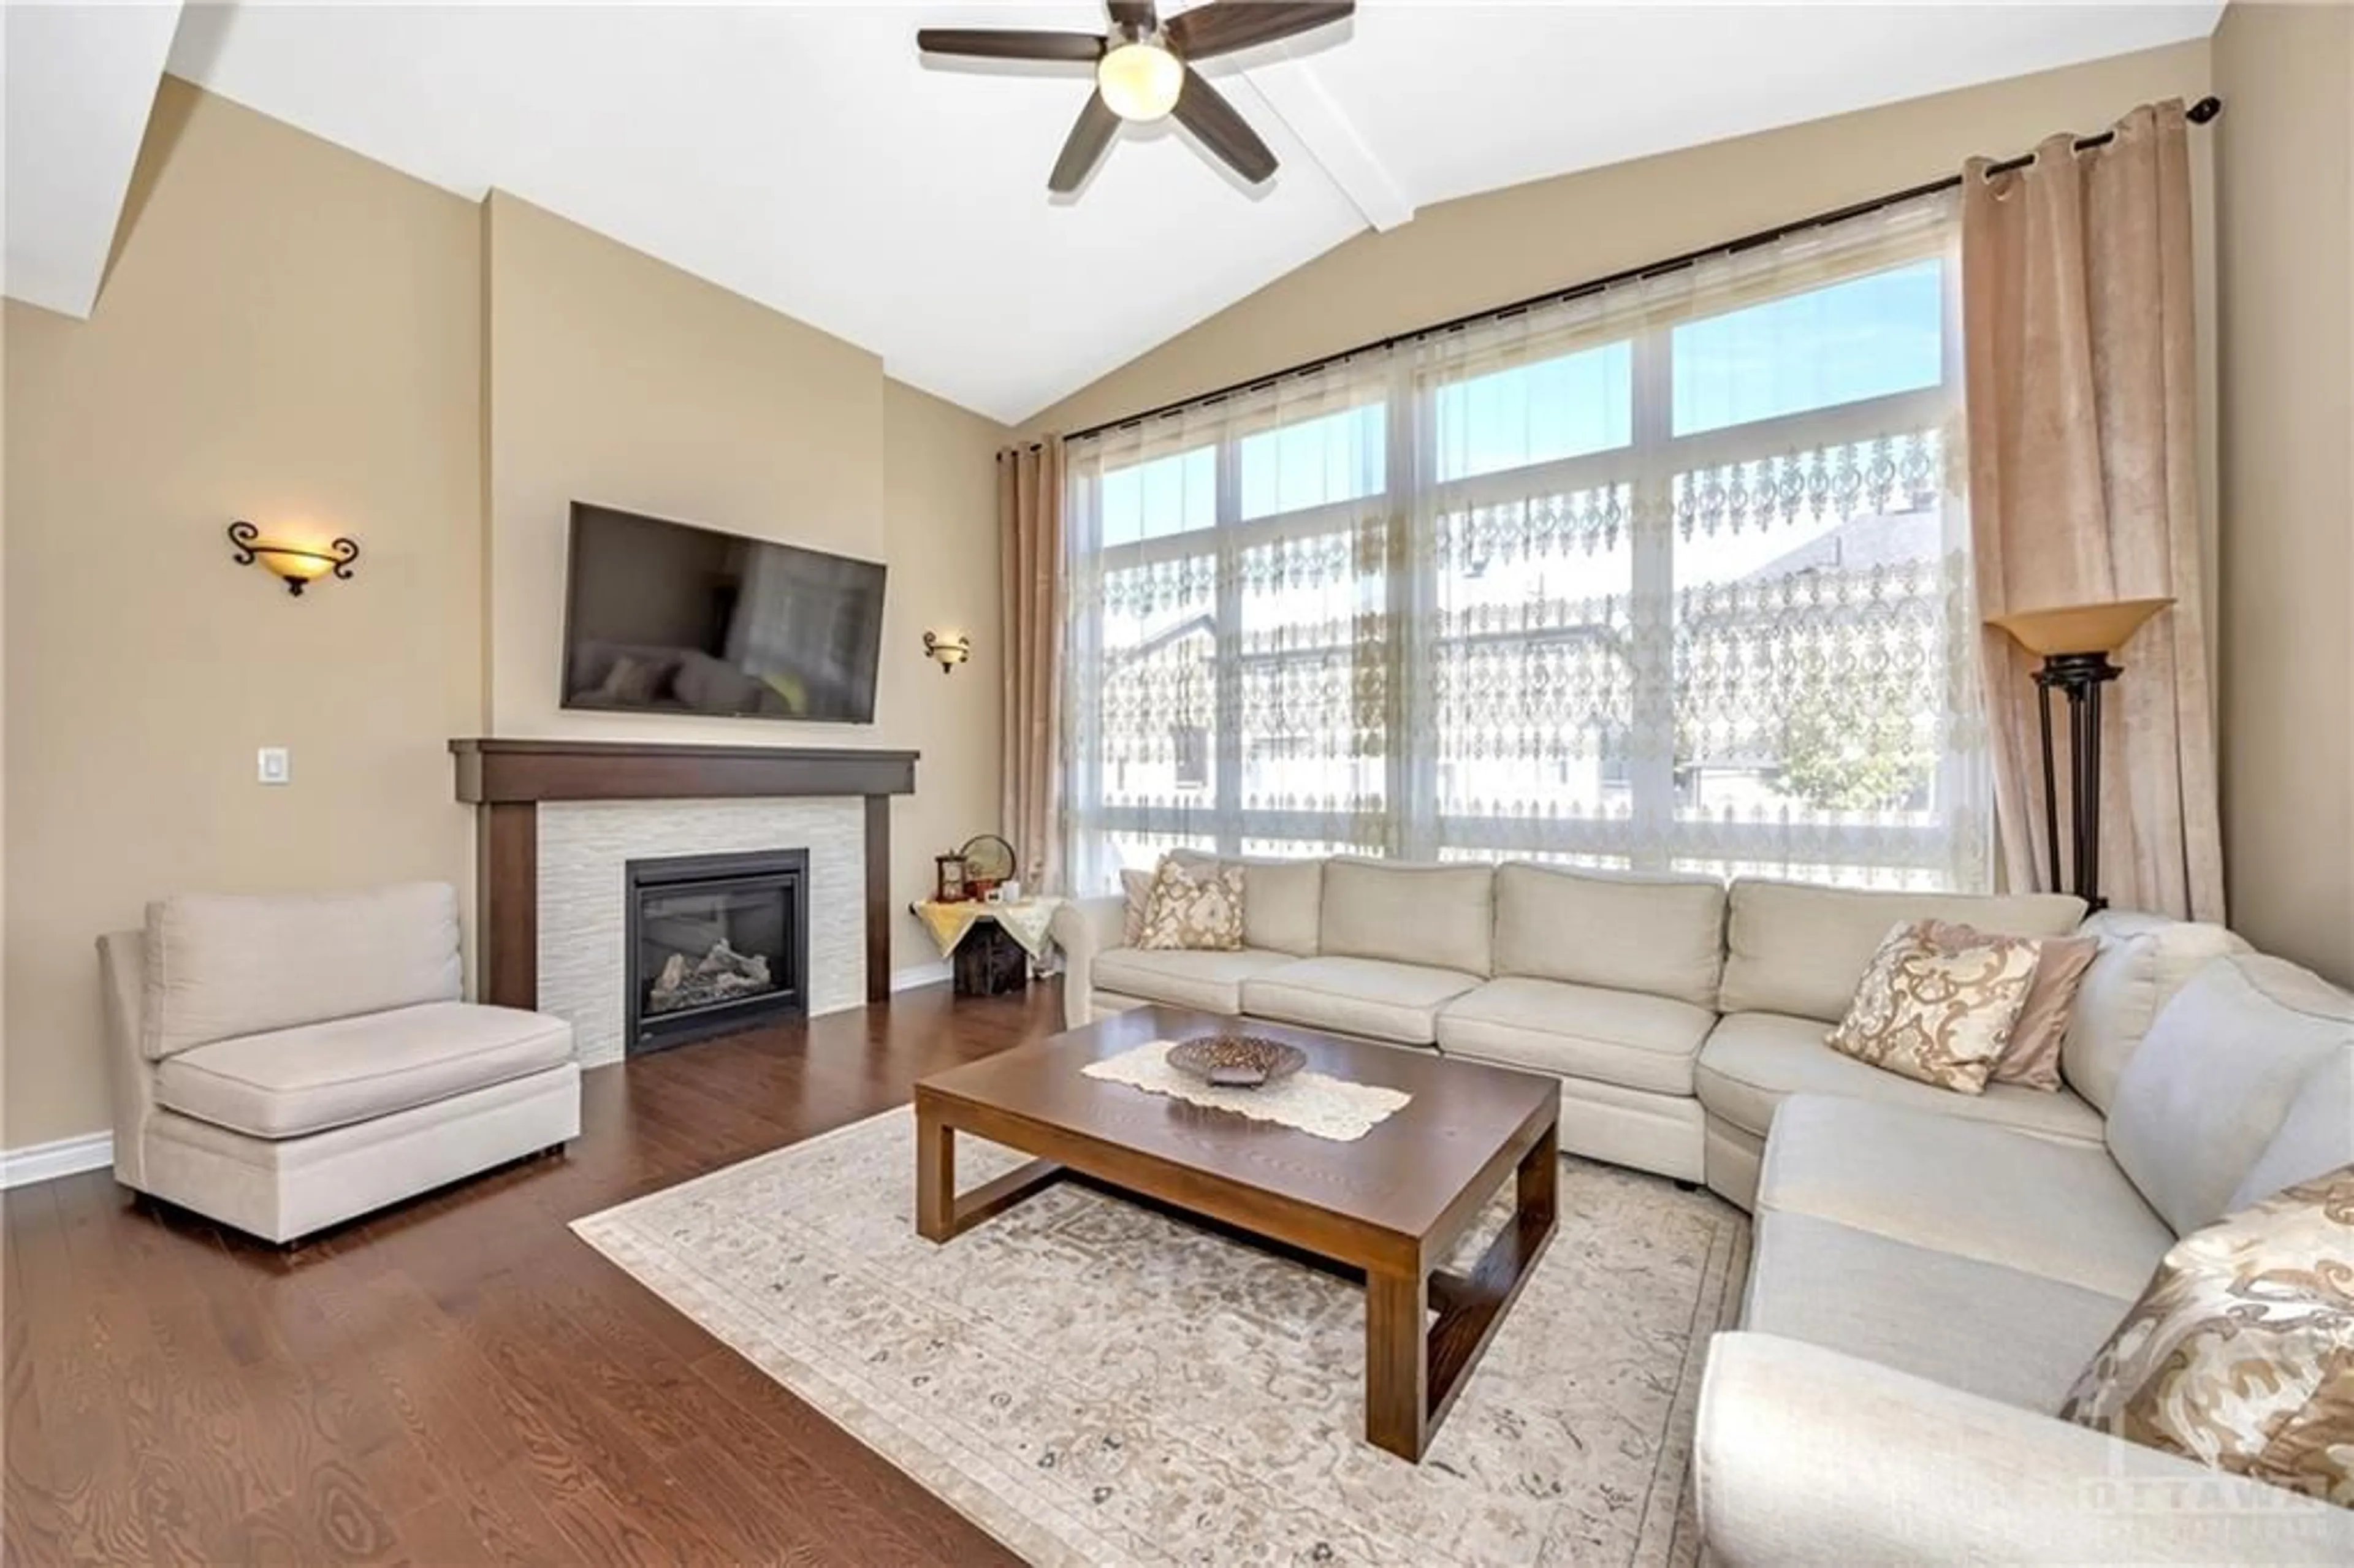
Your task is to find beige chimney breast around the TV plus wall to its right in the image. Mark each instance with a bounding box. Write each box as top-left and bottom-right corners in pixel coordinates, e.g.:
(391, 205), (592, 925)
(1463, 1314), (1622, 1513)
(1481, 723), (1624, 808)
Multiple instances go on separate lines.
(487, 193), (1010, 970)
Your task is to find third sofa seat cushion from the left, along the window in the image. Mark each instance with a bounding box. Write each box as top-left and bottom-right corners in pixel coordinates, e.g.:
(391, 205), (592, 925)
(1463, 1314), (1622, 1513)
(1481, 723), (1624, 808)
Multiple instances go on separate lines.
(1438, 977), (1716, 1095)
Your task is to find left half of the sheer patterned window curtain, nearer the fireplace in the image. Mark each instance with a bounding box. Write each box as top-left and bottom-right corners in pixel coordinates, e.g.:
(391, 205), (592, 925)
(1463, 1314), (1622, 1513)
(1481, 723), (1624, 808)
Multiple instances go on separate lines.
(1064, 365), (1396, 890)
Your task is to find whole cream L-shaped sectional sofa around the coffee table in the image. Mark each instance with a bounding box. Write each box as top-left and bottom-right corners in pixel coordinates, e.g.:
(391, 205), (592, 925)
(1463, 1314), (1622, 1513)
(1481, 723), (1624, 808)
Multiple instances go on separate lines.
(1059, 859), (2354, 1566)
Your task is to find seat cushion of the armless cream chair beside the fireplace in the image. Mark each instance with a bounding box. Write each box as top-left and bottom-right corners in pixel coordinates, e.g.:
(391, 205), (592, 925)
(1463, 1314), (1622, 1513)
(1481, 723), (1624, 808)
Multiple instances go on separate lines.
(155, 1003), (572, 1137)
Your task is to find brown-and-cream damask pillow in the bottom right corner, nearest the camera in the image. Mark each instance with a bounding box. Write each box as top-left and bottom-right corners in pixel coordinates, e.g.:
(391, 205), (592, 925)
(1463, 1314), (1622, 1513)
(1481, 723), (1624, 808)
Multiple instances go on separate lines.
(2060, 1165), (2354, 1507)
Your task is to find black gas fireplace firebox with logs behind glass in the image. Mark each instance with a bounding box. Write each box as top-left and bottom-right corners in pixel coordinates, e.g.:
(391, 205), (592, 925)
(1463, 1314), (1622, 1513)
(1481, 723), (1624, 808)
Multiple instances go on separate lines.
(624, 850), (810, 1057)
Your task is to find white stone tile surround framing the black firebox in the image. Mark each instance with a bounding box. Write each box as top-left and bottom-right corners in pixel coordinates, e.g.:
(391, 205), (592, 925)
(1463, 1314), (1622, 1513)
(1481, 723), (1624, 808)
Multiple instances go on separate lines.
(539, 796), (866, 1067)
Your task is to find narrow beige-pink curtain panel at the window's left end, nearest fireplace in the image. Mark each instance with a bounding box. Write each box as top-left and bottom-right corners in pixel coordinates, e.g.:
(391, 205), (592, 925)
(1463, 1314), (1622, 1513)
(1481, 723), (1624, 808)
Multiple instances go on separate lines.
(998, 436), (1064, 892)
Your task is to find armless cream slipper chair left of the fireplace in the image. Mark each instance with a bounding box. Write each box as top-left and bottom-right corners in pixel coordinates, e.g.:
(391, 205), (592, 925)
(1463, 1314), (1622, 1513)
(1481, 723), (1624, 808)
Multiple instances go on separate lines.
(99, 883), (579, 1241)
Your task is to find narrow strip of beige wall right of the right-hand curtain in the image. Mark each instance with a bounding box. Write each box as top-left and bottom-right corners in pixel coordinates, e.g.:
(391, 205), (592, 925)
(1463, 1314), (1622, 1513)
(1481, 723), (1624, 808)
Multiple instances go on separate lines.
(2215, 0), (2354, 984)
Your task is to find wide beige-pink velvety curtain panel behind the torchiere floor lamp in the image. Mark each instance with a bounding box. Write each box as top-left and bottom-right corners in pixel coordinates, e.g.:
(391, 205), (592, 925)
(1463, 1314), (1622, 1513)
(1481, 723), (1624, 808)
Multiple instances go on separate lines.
(1961, 101), (2225, 921)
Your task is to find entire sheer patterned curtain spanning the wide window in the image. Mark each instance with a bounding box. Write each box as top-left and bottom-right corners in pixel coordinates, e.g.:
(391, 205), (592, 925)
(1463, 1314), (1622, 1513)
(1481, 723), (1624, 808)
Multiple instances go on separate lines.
(1064, 200), (1989, 890)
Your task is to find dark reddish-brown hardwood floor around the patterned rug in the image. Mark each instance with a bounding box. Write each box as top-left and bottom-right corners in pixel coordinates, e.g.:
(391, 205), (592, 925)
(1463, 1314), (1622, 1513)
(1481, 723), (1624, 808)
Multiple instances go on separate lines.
(0, 986), (1059, 1568)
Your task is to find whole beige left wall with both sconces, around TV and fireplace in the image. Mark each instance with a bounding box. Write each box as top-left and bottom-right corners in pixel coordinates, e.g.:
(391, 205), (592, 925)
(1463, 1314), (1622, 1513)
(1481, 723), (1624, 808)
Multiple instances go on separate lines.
(0, 97), (1008, 1149)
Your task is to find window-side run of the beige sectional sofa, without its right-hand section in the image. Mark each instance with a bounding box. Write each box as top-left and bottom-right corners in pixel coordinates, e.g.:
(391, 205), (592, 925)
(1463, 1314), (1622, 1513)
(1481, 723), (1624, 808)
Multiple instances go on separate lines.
(1054, 857), (2100, 1206)
